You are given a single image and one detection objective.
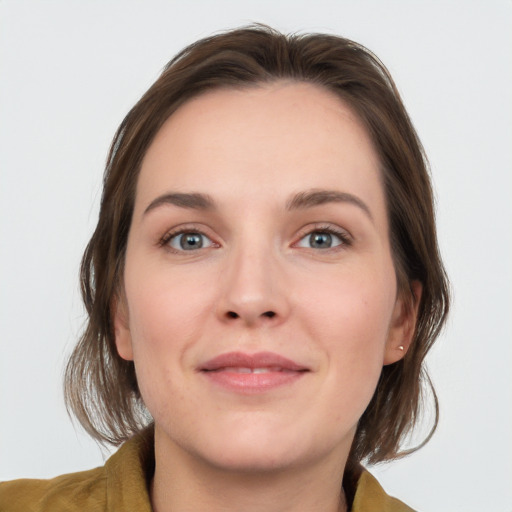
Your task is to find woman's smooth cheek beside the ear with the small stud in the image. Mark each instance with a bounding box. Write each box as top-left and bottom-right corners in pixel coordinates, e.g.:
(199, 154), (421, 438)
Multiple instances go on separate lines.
(302, 266), (395, 390)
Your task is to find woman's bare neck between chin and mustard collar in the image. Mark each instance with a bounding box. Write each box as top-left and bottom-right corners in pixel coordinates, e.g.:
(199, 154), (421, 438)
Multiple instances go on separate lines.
(150, 428), (347, 512)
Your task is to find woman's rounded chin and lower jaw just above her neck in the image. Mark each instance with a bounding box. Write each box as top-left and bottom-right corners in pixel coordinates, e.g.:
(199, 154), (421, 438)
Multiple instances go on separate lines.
(157, 406), (353, 474)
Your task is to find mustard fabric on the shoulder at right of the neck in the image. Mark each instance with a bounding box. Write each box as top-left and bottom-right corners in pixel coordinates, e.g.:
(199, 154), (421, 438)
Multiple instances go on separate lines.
(351, 470), (414, 512)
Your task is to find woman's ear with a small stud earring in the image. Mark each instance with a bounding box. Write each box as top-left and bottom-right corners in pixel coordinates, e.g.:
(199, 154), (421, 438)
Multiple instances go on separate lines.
(383, 281), (423, 366)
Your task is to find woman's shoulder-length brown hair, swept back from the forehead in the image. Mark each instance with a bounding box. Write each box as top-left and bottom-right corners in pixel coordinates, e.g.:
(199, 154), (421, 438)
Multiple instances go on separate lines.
(65, 25), (449, 463)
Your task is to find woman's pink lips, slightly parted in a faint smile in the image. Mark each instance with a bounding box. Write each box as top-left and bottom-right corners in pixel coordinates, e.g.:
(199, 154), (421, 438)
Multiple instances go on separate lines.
(199, 352), (310, 393)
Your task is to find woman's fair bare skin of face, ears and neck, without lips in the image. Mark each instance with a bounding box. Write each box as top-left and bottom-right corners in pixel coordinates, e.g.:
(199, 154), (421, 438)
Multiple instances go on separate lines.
(114, 82), (415, 512)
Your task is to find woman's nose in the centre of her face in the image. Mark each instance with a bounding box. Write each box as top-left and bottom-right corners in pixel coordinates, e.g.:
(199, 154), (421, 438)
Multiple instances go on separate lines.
(218, 241), (290, 327)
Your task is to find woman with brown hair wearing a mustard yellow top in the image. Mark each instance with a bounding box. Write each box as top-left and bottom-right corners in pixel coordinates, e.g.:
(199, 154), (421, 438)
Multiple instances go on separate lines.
(0, 26), (448, 512)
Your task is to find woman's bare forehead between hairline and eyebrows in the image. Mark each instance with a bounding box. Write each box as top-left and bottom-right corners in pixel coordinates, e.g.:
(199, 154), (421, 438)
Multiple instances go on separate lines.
(136, 82), (383, 216)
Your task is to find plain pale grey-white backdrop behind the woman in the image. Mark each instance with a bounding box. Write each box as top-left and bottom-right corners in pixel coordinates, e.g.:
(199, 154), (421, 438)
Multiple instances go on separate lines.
(0, 0), (512, 512)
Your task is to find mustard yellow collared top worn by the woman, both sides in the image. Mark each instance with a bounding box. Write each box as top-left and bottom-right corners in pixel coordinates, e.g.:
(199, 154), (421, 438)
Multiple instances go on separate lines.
(0, 435), (414, 512)
